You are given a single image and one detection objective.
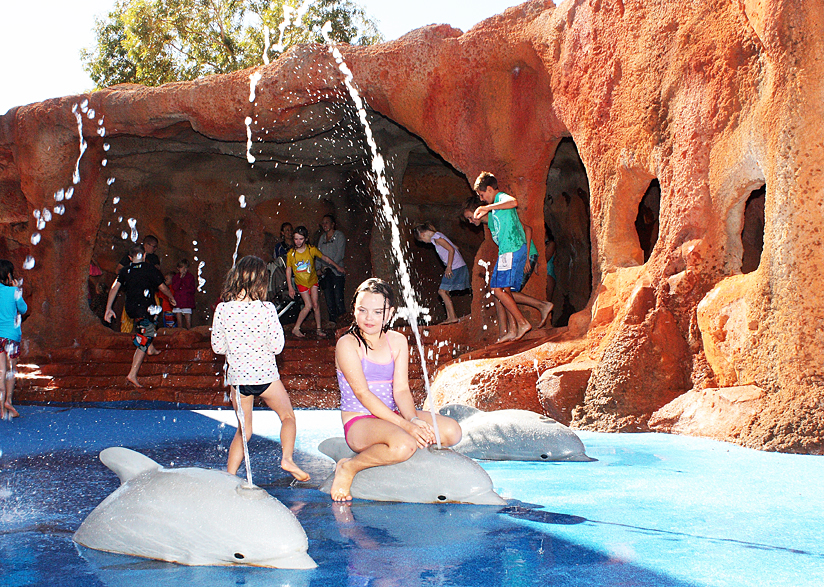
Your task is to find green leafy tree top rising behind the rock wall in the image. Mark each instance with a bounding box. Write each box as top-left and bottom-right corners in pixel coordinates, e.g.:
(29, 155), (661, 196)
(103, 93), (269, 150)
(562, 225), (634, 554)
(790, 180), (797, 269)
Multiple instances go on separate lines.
(82, 0), (383, 88)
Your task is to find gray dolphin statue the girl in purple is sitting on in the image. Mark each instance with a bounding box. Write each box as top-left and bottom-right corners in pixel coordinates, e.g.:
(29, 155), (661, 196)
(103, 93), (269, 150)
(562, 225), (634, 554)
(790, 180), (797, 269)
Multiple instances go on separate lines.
(318, 437), (506, 505)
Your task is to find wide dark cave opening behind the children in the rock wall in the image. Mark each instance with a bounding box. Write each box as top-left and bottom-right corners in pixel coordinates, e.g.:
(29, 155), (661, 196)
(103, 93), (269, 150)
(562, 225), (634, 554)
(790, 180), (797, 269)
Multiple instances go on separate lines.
(87, 103), (483, 325)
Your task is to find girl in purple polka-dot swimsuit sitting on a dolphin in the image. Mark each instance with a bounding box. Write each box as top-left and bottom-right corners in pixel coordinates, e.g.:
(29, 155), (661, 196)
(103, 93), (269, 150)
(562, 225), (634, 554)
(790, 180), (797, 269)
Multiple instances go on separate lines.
(331, 278), (461, 501)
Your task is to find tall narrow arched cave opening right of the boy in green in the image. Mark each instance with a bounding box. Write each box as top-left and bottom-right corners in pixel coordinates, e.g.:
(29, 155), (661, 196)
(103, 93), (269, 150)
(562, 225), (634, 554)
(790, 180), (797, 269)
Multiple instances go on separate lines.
(544, 137), (592, 326)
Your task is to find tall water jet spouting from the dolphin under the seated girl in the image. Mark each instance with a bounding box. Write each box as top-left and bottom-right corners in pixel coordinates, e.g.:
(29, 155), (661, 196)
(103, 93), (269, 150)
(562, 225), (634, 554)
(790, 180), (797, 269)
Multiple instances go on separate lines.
(321, 21), (441, 448)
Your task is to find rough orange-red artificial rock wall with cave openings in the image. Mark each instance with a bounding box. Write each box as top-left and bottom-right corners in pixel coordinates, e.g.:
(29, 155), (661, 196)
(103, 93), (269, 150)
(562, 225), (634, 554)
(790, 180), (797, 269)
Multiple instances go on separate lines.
(0, 0), (824, 452)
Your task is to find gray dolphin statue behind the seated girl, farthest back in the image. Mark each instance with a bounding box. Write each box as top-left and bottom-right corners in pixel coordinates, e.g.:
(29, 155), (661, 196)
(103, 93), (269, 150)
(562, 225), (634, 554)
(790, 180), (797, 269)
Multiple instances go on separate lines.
(439, 404), (595, 462)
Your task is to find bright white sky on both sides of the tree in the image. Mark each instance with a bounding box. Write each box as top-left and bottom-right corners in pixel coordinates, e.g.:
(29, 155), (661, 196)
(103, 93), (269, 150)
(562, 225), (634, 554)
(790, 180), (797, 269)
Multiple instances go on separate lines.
(0, 0), (523, 115)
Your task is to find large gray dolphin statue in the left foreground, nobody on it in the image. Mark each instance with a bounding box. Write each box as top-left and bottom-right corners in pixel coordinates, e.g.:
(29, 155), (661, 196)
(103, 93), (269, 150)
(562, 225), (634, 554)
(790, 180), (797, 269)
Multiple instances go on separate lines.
(74, 447), (317, 569)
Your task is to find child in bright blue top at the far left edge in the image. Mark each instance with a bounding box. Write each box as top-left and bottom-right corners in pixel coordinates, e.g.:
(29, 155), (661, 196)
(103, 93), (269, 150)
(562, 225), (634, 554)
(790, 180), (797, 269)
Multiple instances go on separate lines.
(0, 259), (28, 420)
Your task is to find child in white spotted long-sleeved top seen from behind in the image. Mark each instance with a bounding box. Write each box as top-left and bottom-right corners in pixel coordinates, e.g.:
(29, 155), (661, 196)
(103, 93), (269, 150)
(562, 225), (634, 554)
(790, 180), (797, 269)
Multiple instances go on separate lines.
(212, 256), (309, 481)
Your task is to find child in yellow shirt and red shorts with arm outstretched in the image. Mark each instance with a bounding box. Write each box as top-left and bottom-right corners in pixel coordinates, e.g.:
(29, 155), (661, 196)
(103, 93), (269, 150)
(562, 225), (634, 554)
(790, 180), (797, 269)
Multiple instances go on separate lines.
(286, 226), (346, 338)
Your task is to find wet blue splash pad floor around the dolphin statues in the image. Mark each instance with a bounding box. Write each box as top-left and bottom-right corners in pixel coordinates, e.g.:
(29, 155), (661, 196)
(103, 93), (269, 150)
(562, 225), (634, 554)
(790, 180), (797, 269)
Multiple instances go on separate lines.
(0, 406), (824, 587)
